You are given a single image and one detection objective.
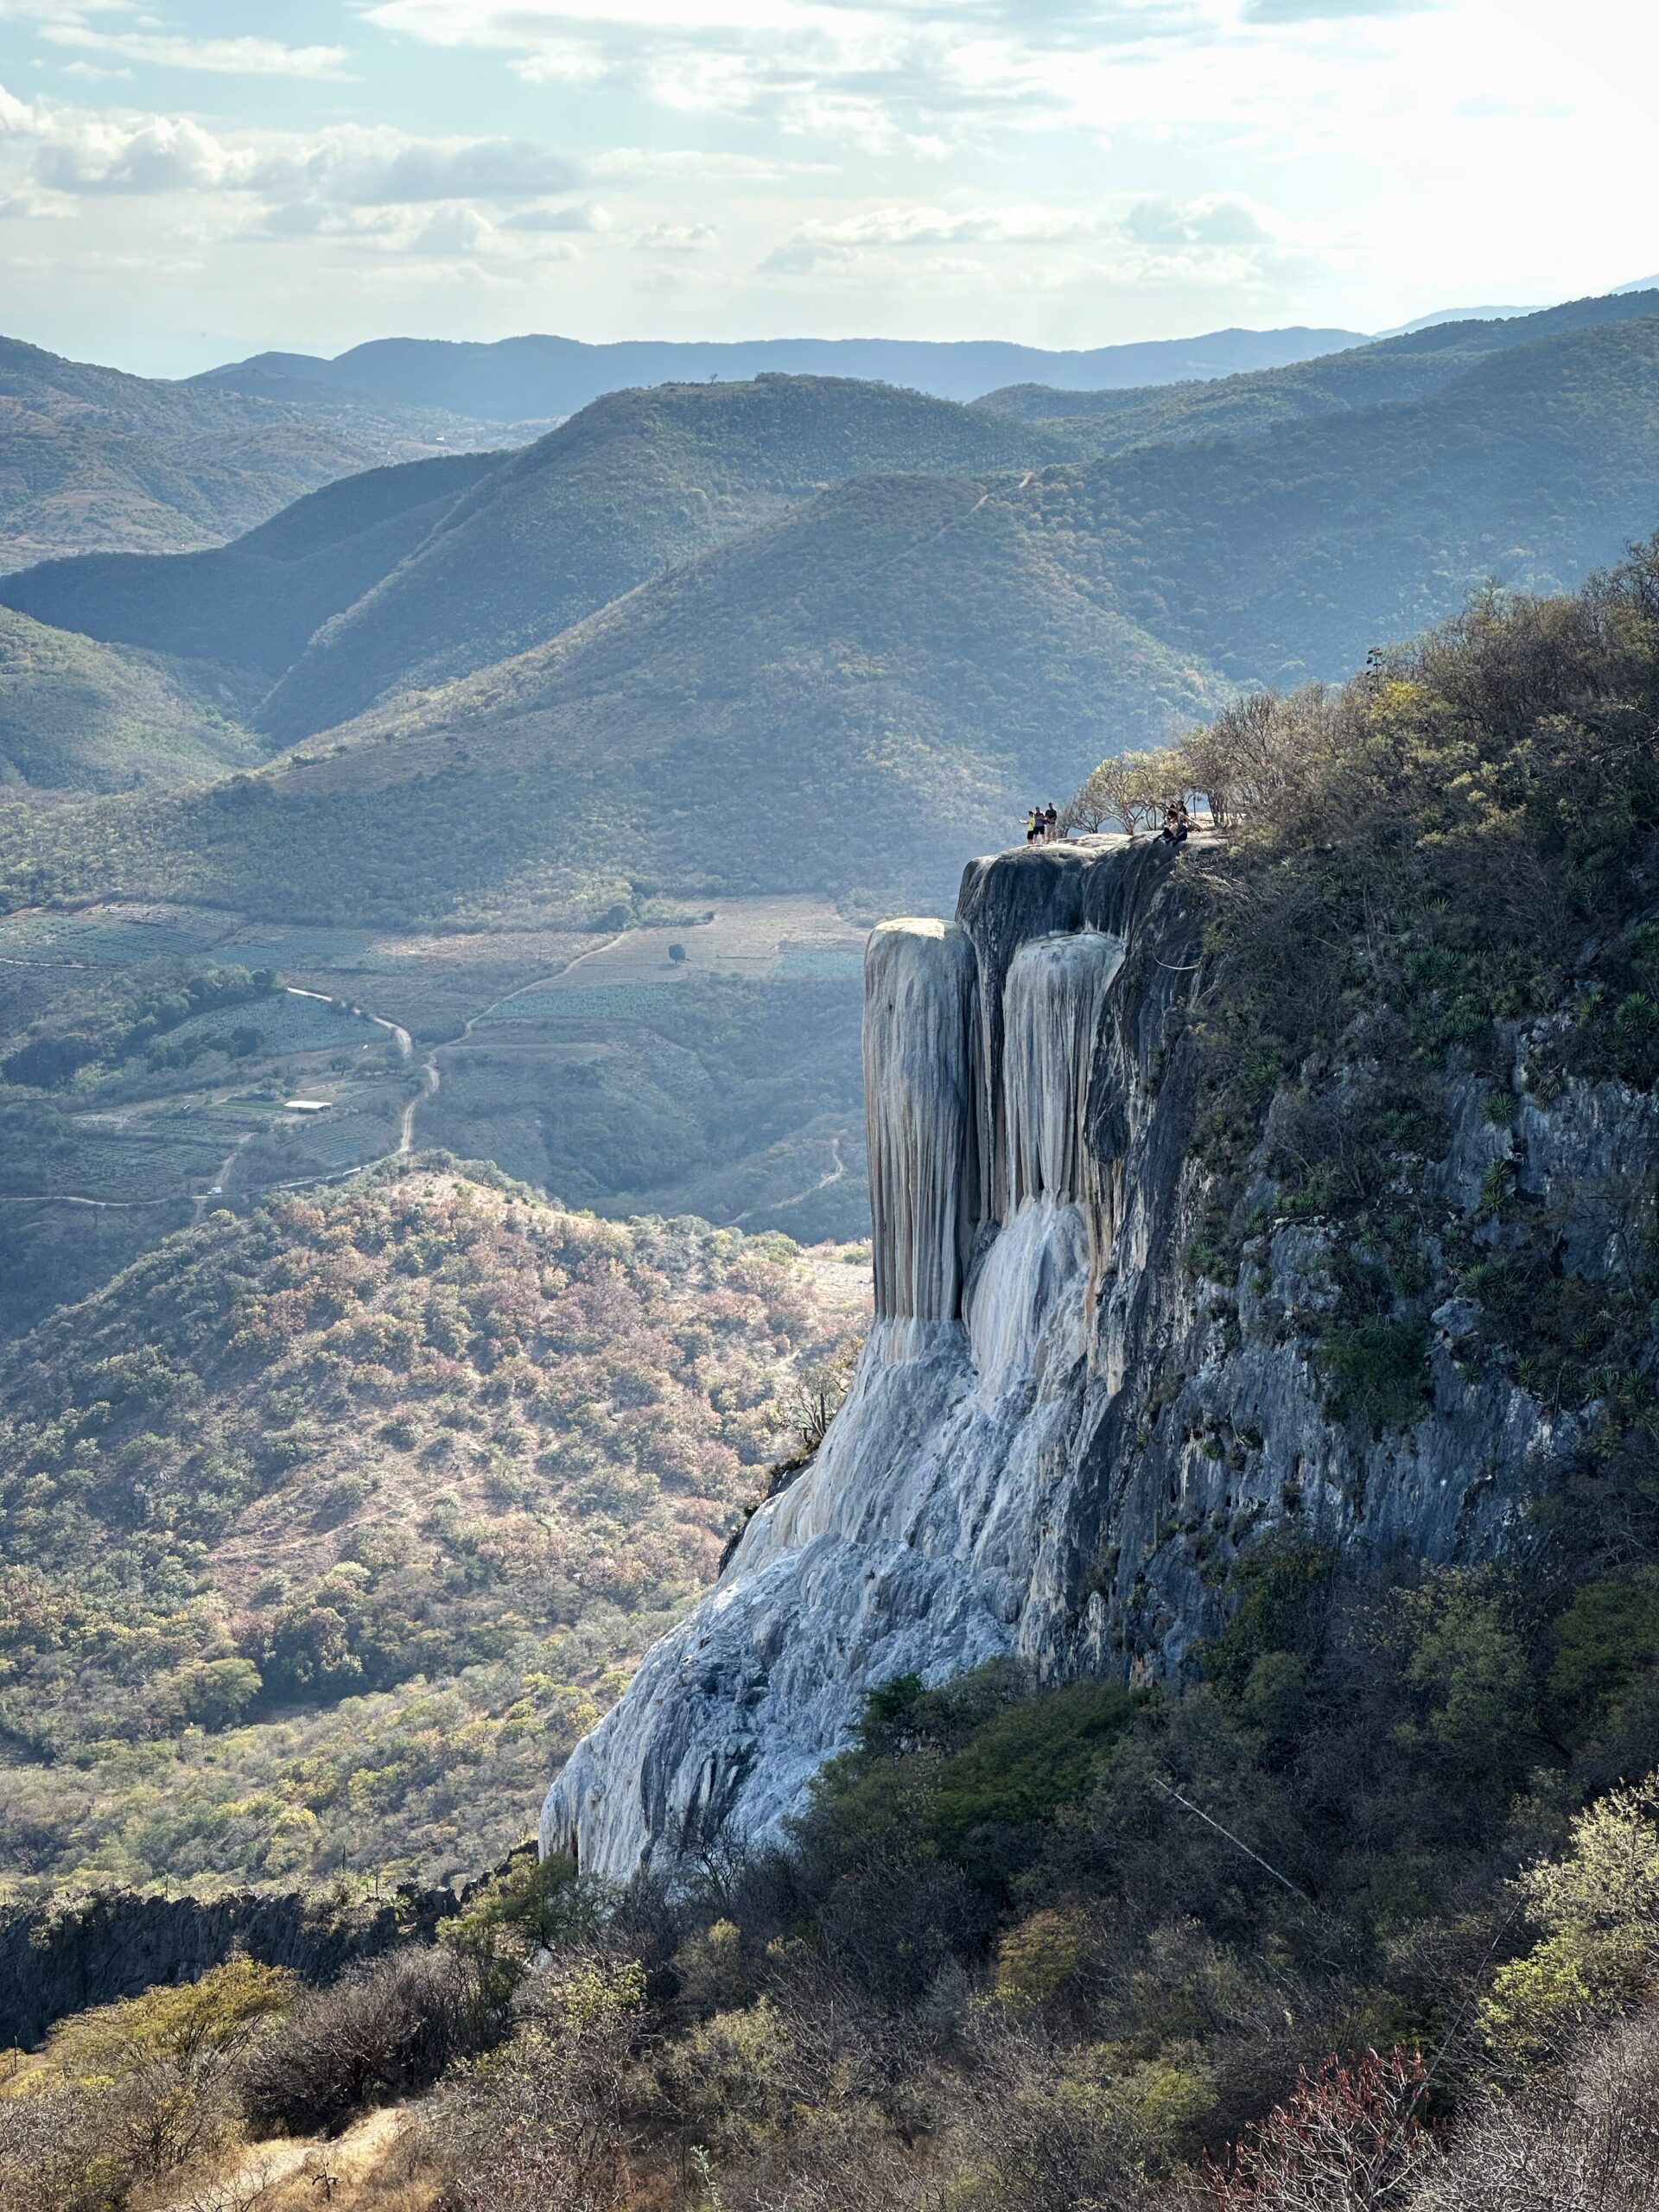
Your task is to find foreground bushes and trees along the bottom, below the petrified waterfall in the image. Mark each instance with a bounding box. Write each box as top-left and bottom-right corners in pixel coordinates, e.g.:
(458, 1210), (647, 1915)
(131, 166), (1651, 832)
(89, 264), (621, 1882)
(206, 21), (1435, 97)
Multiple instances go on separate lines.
(13, 1551), (1659, 2212)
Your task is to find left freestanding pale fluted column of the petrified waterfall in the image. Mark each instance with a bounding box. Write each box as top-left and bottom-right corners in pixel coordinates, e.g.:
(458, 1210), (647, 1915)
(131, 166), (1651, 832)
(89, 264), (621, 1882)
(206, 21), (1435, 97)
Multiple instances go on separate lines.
(865, 920), (976, 1320)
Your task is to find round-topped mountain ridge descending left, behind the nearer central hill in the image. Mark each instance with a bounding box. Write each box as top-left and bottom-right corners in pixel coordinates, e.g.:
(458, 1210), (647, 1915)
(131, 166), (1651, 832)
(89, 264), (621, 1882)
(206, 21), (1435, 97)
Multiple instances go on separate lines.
(0, 376), (1075, 741)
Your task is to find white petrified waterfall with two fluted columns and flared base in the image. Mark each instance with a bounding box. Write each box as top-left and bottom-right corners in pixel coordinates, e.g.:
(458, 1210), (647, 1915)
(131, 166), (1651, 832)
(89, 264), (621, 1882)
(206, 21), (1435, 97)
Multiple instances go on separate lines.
(542, 847), (1161, 1876)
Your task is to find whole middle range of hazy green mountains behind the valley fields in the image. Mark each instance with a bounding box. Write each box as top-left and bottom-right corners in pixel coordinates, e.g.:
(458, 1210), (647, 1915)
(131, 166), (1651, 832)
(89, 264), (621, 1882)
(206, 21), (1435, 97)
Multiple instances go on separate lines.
(0, 294), (1659, 918)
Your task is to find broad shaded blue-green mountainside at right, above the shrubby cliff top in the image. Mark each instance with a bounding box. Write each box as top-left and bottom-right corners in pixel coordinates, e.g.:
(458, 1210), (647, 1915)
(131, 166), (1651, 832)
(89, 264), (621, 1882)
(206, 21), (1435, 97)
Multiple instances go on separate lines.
(1057, 316), (1659, 683)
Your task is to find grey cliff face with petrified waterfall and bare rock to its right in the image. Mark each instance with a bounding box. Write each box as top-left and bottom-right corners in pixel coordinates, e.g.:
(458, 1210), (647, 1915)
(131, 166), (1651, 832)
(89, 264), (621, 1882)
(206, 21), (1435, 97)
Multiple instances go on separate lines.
(542, 841), (1659, 1878)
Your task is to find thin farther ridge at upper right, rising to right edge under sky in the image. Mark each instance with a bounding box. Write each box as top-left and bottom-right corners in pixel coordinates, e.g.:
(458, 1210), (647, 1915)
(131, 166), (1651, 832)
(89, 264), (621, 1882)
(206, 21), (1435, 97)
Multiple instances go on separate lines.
(980, 292), (1659, 454)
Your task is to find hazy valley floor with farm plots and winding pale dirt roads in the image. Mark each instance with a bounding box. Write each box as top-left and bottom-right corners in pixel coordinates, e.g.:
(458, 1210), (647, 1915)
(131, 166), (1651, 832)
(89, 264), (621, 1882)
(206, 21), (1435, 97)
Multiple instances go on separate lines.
(0, 898), (868, 1325)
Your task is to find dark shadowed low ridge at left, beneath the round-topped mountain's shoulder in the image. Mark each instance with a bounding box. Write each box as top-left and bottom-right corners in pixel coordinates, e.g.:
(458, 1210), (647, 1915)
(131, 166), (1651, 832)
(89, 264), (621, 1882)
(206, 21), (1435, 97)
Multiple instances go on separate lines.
(0, 454), (500, 677)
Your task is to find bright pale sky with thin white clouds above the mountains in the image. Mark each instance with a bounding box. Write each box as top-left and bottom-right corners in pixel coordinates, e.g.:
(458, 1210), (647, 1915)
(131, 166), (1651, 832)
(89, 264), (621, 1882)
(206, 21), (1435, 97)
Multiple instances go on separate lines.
(0, 0), (1659, 376)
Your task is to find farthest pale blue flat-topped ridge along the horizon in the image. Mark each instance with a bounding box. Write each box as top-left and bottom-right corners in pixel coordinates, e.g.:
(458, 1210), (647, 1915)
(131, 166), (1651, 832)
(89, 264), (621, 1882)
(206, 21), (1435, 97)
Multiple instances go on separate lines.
(193, 329), (1360, 423)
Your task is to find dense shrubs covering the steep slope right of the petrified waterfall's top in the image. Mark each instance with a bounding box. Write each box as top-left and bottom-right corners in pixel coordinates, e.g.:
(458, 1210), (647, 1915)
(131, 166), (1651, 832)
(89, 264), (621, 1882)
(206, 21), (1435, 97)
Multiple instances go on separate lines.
(1096, 540), (1659, 1459)
